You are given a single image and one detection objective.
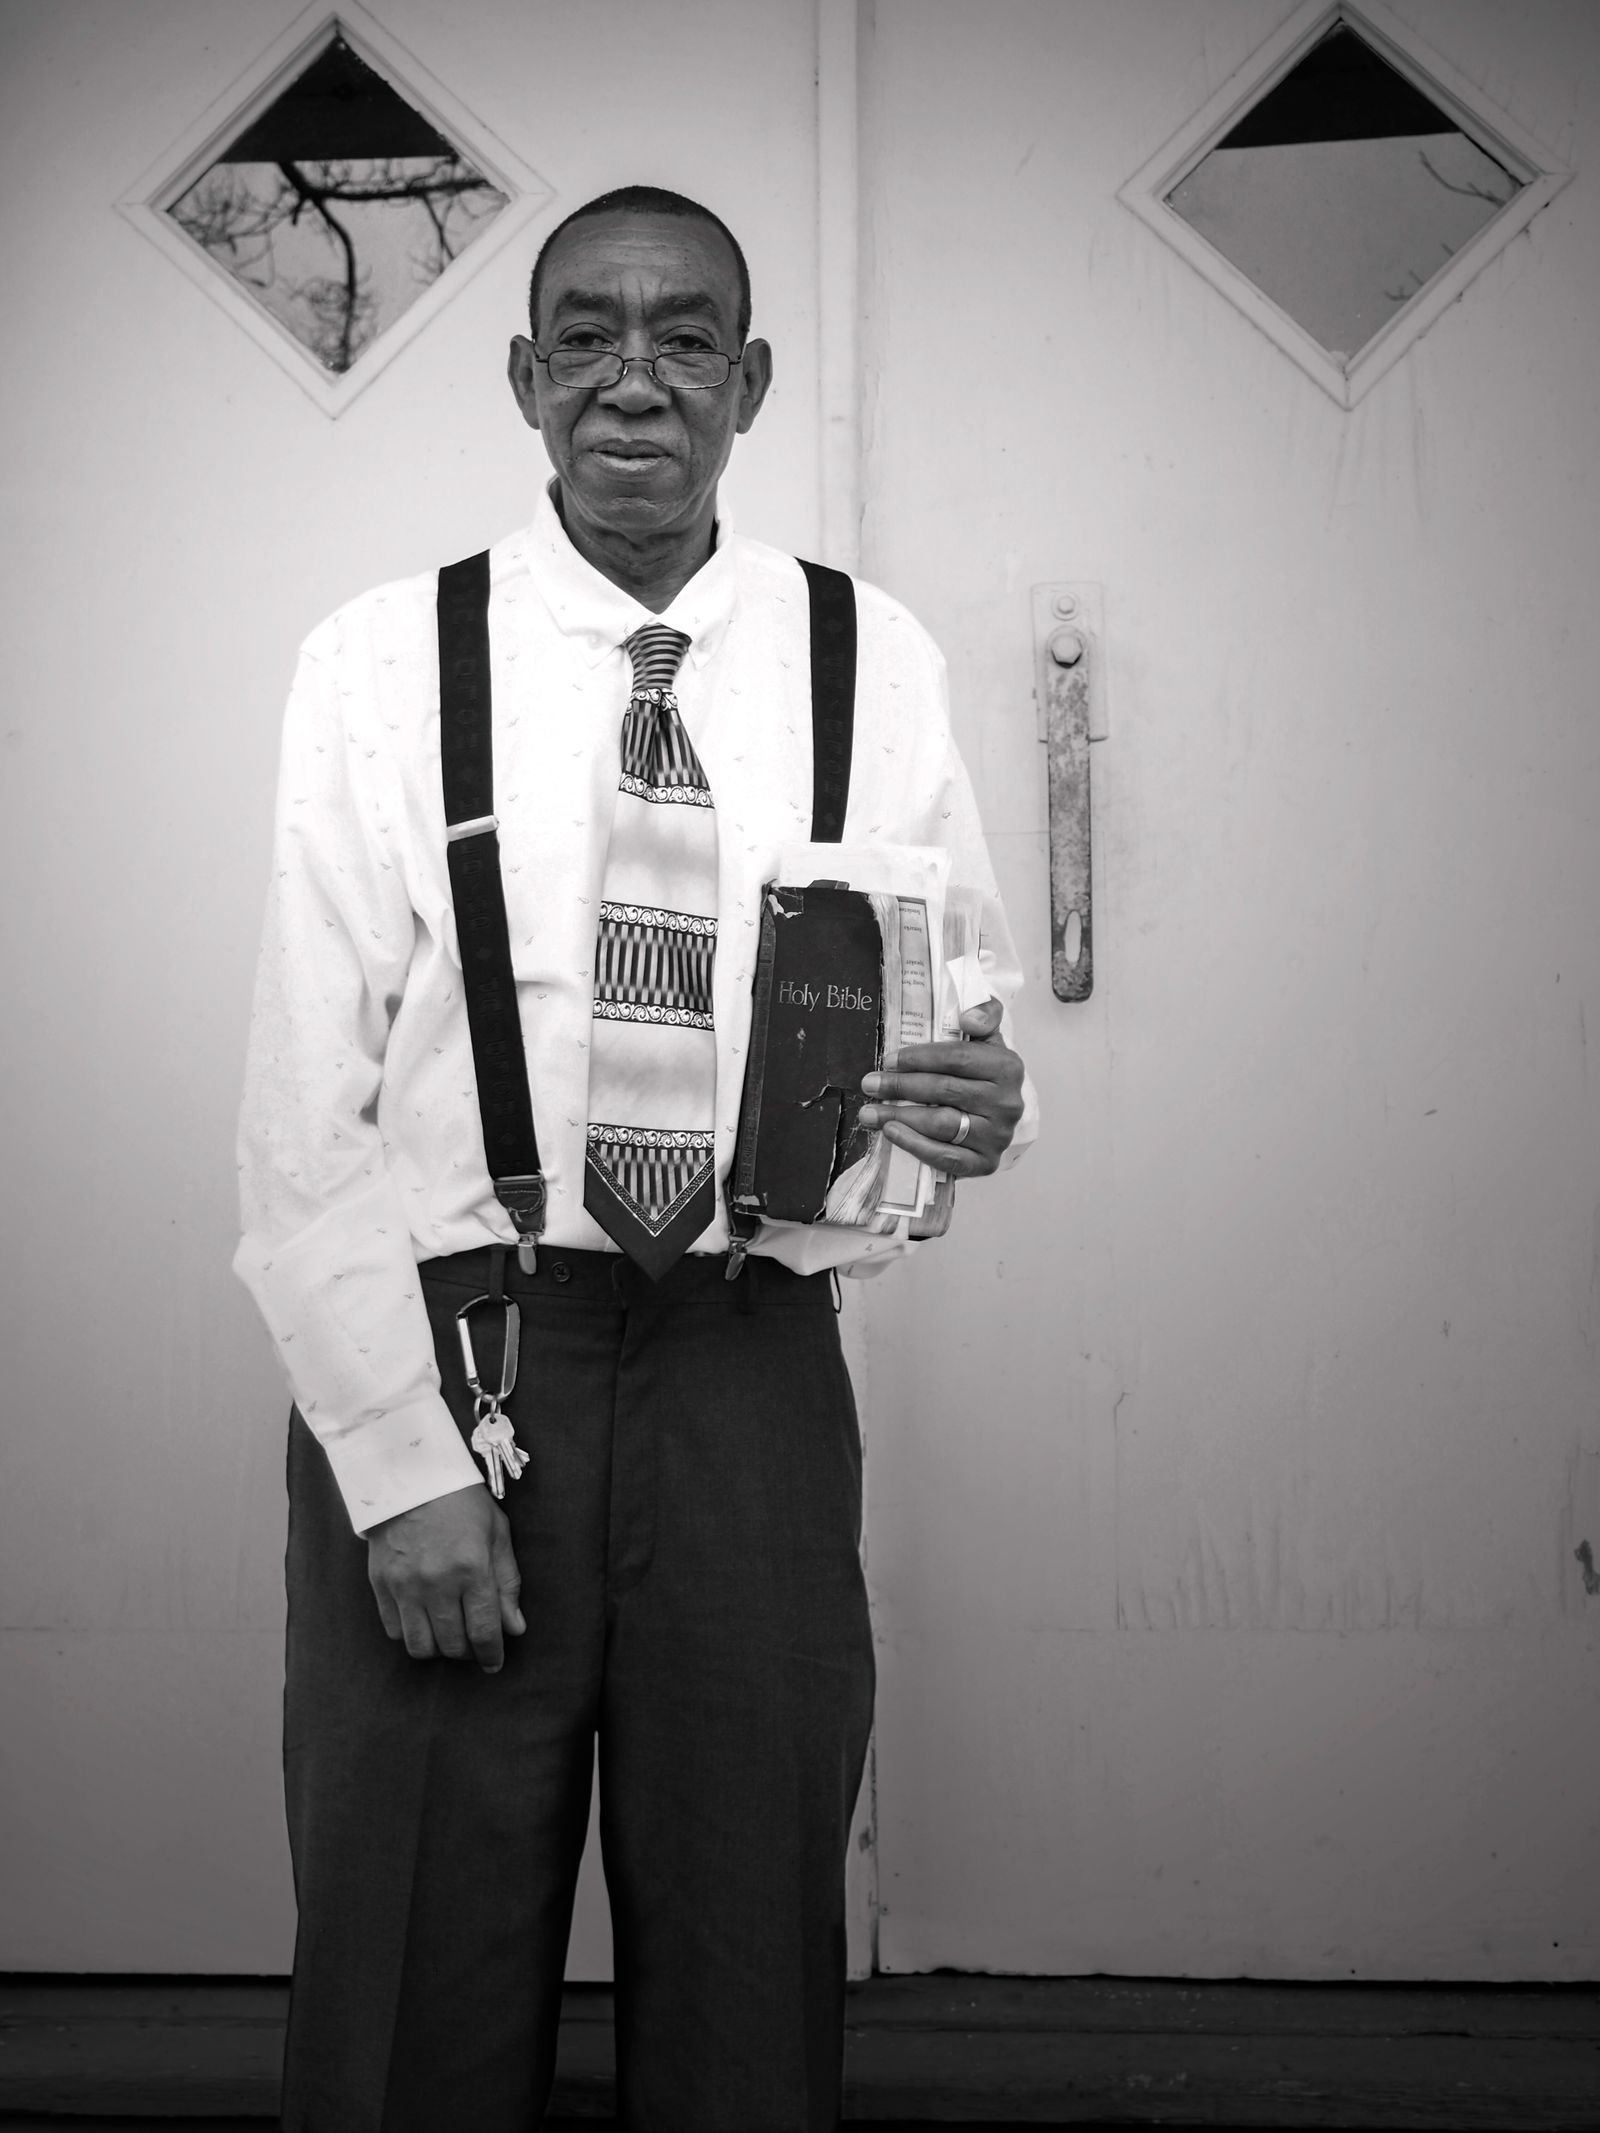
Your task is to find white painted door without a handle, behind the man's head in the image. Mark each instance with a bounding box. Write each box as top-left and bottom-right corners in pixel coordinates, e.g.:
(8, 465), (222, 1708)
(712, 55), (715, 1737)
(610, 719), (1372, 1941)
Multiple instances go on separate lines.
(0, 0), (840, 1973)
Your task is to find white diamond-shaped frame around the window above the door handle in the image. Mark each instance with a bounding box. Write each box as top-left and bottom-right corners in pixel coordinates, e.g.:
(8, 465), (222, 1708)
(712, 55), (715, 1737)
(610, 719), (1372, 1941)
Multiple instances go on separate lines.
(1118, 0), (1572, 407)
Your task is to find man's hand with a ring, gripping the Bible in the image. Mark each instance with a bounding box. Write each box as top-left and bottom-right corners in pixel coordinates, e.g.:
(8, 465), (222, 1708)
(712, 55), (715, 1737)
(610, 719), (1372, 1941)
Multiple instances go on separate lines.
(862, 1000), (1022, 1177)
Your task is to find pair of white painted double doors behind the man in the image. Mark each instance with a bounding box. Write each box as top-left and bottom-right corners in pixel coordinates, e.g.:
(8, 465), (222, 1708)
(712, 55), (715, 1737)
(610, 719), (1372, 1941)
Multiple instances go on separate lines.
(0, 0), (1600, 1977)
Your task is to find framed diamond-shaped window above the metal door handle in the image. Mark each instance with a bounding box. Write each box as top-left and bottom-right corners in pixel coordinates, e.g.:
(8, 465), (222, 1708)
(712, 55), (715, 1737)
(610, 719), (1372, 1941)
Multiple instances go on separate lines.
(1122, 4), (1564, 405)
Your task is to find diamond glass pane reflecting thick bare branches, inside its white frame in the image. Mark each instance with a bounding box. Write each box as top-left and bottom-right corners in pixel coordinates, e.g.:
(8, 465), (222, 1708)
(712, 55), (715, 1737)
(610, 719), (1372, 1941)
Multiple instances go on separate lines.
(166, 36), (506, 373)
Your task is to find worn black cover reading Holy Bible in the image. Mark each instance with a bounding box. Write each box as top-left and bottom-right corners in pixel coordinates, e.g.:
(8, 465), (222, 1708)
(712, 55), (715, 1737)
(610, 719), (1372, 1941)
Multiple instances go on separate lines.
(730, 881), (883, 1222)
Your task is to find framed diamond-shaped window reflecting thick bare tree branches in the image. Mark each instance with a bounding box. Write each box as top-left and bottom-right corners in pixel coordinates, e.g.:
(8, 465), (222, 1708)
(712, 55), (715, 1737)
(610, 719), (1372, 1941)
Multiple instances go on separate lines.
(124, 6), (548, 414)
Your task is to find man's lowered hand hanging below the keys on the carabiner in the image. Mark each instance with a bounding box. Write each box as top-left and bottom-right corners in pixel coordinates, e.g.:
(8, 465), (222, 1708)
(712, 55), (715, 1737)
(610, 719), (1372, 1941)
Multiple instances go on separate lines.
(367, 1487), (527, 1674)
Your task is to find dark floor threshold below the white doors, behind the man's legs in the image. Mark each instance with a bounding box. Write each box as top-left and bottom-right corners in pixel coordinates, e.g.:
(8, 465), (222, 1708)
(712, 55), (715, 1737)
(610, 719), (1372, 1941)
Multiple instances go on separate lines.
(0, 1973), (1600, 2133)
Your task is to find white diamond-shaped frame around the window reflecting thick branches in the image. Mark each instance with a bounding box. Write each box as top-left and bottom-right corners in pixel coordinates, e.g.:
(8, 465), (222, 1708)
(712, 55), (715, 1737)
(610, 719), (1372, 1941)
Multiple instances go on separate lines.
(117, 0), (553, 418)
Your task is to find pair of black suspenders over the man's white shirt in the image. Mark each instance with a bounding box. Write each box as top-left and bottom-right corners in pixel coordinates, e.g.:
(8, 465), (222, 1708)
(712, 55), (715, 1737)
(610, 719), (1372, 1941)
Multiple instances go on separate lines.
(439, 550), (855, 1273)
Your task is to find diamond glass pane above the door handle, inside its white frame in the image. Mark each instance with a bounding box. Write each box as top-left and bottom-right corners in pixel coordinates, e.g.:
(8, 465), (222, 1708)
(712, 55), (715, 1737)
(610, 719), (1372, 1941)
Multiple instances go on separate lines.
(1167, 26), (1521, 360)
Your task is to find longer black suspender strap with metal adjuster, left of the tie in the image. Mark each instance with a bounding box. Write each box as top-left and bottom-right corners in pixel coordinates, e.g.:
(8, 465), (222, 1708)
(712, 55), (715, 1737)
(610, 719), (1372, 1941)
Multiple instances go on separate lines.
(439, 550), (544, 1273)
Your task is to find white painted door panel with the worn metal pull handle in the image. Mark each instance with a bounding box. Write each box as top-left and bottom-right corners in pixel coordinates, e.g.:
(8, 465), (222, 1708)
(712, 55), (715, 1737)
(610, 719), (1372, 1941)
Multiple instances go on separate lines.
(862, 0), (1600, 1979)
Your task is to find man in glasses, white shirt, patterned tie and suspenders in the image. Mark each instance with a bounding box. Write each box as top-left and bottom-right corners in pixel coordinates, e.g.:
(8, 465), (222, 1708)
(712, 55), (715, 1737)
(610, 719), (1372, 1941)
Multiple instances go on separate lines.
(237, 188), (1041, 2133)
